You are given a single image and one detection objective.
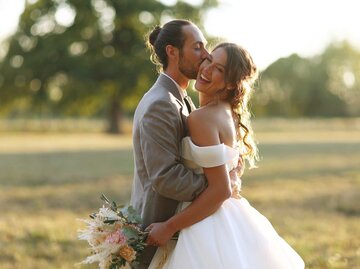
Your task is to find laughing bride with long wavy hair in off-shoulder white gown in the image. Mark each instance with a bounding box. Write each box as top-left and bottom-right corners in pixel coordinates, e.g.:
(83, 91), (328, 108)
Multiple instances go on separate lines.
(148, 43), (304, 269)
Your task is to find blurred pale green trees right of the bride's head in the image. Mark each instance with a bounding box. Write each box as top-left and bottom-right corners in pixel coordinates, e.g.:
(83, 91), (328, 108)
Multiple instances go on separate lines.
(254, 42), (360, 117)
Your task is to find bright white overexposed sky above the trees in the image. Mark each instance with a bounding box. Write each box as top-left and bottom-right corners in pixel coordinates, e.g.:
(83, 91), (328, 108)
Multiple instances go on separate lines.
(0, 0), (360, 69)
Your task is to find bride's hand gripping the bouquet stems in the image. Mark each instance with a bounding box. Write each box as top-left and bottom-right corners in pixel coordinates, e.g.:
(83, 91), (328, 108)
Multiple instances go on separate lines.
(145, 222), (176, 247)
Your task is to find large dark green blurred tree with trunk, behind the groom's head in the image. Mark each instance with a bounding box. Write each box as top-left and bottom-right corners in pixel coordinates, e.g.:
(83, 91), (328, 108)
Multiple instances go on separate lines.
(0, 0), (217, 133)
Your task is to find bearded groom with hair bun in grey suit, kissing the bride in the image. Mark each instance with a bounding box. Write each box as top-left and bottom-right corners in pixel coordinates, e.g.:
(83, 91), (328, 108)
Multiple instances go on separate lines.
(131, 20), (209, 269)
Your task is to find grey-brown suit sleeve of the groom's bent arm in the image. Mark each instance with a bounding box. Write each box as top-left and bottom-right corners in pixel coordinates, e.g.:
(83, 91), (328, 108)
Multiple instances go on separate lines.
(140, 100), (206, 201)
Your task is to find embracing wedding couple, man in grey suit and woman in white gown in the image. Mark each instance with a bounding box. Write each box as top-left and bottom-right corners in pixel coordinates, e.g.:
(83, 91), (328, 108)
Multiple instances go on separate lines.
(131, 20), (304, 269)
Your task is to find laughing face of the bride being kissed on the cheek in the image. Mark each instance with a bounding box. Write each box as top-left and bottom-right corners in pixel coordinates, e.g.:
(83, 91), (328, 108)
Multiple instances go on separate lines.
(195, 48), (227, 96)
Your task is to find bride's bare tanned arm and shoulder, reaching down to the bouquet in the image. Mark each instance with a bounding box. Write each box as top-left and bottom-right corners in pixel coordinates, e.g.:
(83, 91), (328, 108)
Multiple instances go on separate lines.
(148, 108), (231, 246)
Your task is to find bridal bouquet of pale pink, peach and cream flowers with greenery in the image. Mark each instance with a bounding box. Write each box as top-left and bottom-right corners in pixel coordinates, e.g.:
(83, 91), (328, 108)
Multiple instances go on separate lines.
(78, 195), (147, 269)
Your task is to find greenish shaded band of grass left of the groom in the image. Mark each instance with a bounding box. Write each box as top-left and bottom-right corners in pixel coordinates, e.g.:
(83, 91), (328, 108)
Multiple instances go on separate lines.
(0, 150), (133, 187)
